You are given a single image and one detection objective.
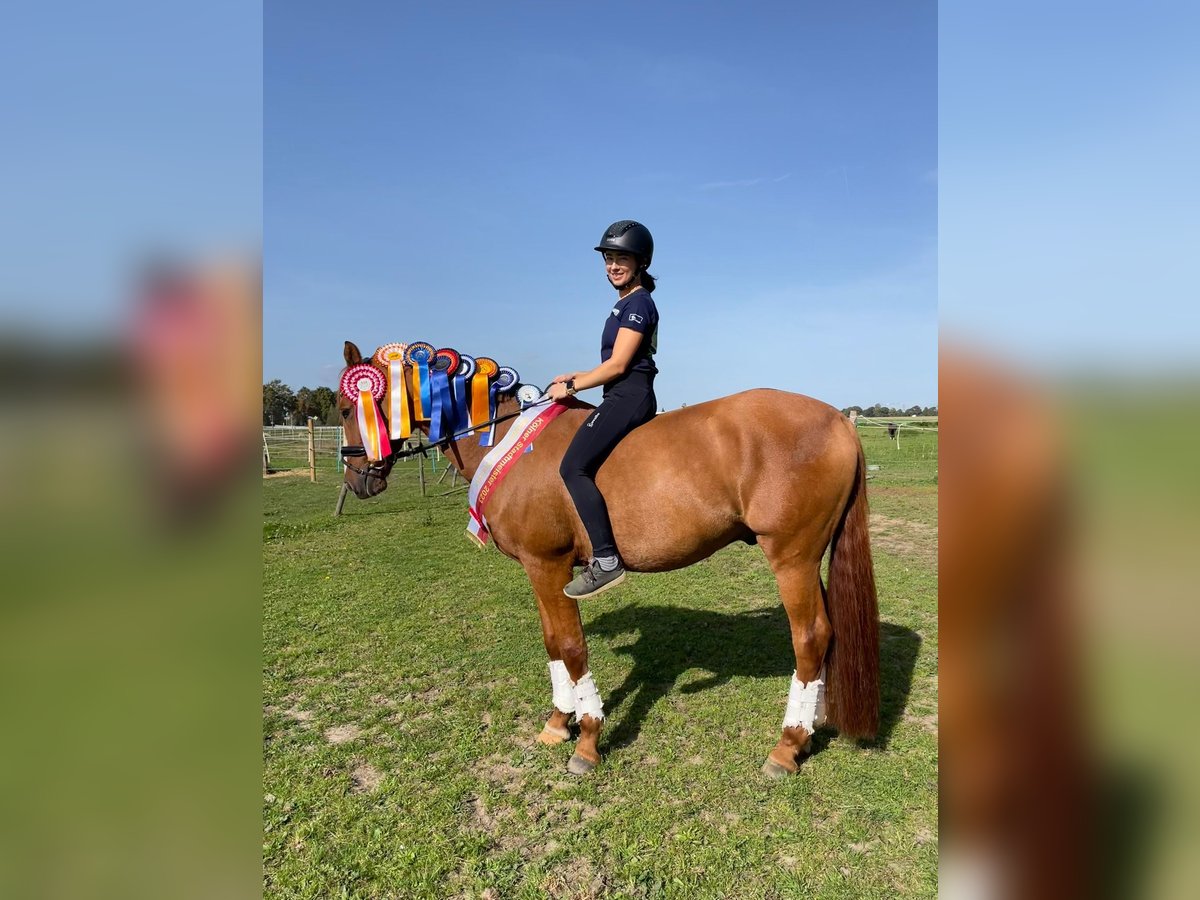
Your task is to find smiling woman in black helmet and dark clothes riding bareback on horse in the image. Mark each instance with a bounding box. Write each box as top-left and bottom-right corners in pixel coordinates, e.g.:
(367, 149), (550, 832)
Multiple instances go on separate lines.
(550, 220), (659, 600)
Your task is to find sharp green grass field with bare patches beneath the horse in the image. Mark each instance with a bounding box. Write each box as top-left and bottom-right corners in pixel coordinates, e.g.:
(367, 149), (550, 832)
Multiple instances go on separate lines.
(263, 430), (937, 900)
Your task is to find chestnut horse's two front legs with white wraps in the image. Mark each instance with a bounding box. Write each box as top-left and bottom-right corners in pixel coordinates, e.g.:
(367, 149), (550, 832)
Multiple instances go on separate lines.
(524, 558), (604, 775)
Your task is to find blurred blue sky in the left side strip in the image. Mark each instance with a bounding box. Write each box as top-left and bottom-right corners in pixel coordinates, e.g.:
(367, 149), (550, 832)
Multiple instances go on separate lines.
(0, 0), (263, 336)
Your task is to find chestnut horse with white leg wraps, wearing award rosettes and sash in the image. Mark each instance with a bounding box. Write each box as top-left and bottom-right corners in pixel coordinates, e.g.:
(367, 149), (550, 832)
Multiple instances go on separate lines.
(338, 341), (880, 776)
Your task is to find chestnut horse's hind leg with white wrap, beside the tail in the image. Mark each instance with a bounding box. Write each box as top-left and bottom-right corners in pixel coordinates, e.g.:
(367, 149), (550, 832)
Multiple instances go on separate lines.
(762, 547), (832, 776)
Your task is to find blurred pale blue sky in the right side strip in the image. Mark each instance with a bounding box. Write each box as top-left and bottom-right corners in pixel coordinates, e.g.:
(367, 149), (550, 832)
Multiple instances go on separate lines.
(938, 0), (1200, 372)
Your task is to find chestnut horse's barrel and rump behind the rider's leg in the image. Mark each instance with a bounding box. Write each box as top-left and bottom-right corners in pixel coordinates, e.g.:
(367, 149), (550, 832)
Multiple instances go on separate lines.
(596, 389), (858, 571)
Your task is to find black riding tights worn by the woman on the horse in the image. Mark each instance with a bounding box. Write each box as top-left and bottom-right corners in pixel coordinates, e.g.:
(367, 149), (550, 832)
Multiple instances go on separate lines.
(558, 377), (658, 557)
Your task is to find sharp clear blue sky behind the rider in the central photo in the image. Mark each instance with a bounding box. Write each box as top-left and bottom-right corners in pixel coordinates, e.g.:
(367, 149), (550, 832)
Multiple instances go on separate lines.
(263, 0), (937, 408)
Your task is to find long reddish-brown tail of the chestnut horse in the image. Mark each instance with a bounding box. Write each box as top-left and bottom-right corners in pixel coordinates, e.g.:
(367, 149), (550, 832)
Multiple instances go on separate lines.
(826, 436), (880, 738)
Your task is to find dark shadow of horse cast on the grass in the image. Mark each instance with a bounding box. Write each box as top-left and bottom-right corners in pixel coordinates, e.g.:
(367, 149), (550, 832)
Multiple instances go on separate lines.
(586, 606), (920, 750)
